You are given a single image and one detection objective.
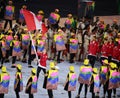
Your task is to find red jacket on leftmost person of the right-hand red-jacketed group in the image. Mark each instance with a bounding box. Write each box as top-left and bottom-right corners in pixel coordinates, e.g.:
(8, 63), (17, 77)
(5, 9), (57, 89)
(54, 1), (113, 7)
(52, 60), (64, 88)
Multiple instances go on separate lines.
(88, 41), (99, 56)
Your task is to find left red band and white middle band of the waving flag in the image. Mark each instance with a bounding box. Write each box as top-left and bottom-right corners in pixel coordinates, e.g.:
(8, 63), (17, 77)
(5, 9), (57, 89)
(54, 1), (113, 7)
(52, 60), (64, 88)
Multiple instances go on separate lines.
(23, 10), (42, 31)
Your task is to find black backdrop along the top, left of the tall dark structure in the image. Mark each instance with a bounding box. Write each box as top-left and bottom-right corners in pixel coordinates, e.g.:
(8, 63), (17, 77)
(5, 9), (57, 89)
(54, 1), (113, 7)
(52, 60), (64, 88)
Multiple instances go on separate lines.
(14, 0), (78, 17)
